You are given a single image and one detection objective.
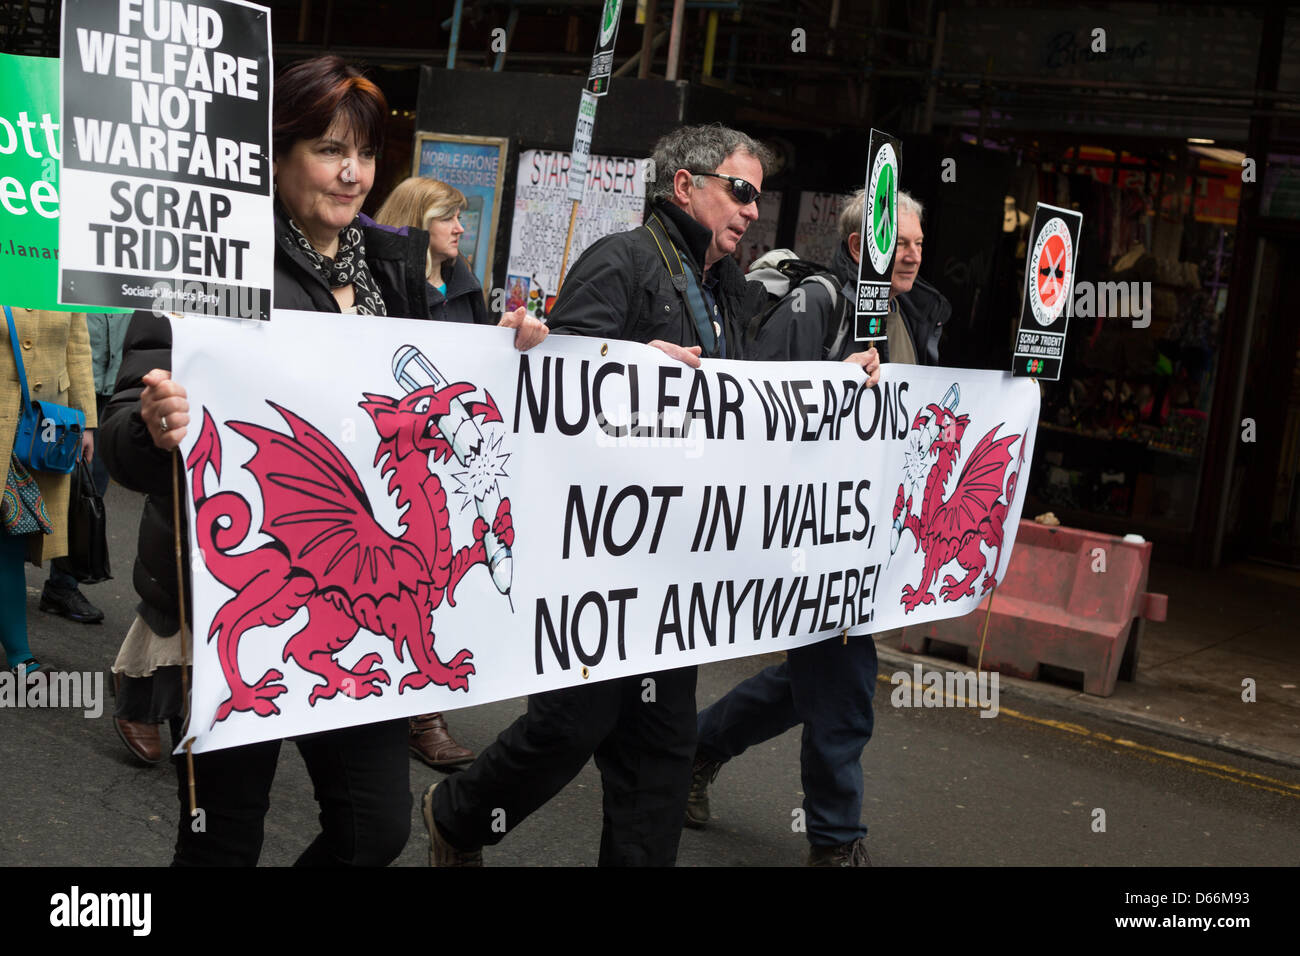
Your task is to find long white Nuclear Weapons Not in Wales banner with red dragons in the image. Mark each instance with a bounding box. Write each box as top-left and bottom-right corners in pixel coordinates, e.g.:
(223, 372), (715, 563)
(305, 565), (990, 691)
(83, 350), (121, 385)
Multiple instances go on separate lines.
(173, 311), (1039, 752)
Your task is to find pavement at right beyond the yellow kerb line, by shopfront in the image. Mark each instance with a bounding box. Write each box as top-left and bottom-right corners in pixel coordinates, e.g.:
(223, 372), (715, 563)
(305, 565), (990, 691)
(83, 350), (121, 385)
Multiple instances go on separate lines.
(876, 561), (1300, 767)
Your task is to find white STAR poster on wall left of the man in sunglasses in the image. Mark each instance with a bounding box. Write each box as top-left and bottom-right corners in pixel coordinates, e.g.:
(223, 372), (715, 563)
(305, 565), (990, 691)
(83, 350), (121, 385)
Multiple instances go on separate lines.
(506, 150), (650, 319)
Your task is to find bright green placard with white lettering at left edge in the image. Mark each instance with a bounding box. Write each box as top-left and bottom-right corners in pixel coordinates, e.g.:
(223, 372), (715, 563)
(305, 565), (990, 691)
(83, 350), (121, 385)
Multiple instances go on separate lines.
(0, 53), (125, 312)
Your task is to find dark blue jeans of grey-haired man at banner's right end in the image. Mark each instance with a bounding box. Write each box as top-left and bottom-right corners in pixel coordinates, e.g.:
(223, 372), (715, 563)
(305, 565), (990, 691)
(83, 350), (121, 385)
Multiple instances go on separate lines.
(699, 635), (878, 845)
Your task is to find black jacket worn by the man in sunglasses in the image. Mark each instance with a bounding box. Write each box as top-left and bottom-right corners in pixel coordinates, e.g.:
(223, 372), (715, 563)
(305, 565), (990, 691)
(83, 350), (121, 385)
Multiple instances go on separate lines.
(547, 202), (763, 359)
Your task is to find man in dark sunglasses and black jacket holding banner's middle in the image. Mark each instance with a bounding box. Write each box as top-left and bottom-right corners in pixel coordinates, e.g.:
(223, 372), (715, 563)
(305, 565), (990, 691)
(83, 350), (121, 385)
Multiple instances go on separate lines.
(424, 125), (876, 866)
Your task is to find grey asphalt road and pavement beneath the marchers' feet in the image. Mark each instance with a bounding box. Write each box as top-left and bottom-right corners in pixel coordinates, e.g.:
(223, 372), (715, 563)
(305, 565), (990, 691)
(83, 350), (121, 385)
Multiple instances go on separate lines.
(0, 485), (1300, 866)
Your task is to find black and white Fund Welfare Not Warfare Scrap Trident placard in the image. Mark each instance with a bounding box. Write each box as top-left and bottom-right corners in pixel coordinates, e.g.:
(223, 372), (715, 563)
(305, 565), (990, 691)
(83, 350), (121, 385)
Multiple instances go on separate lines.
(59, 0), (274, 319)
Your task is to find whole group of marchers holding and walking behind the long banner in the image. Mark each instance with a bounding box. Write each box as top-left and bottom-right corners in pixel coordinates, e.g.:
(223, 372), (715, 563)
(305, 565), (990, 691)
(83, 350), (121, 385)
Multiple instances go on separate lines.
(0, 42), (949, 866)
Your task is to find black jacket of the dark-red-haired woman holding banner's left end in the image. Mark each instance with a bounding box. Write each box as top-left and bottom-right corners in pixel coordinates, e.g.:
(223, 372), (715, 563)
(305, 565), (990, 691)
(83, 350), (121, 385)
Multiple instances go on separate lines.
(95, 217), (432, 636)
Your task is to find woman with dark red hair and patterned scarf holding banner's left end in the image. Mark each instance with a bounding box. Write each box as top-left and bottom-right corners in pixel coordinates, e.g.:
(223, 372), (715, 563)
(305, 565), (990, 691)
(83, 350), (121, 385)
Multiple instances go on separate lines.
(100, 56), (545, 866)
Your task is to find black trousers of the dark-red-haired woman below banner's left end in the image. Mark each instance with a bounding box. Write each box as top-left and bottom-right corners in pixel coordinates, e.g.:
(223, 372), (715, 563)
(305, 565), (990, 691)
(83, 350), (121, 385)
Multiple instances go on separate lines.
(172, 718), (411, 866)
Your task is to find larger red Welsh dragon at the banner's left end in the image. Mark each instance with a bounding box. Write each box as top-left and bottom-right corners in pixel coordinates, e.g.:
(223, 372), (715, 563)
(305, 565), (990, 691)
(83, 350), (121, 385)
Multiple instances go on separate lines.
(186, 350), (515, 723)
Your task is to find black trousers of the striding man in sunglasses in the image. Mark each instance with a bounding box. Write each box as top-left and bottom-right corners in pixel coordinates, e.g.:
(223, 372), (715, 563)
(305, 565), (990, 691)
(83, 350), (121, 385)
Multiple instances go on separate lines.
(433, 667), (696, 866)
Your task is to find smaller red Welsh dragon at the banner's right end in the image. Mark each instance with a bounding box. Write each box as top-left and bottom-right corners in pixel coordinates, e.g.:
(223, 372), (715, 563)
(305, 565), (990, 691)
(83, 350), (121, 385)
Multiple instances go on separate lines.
(891, 385), (1026, 614)
